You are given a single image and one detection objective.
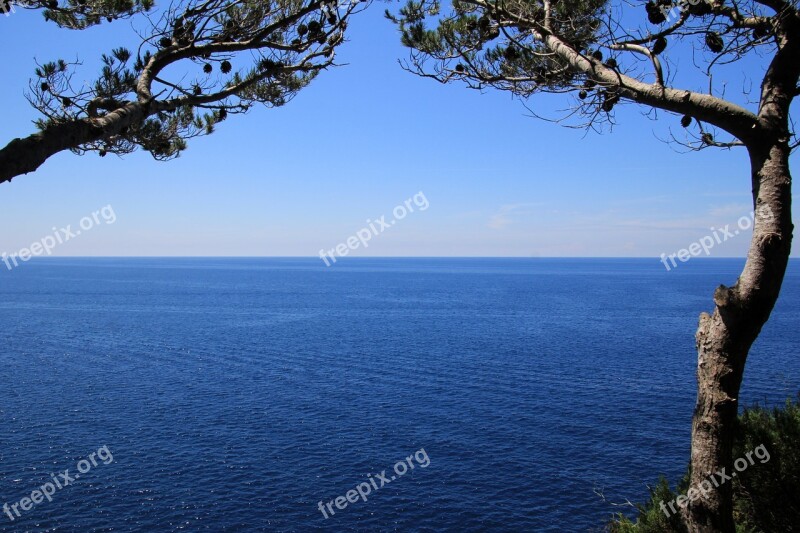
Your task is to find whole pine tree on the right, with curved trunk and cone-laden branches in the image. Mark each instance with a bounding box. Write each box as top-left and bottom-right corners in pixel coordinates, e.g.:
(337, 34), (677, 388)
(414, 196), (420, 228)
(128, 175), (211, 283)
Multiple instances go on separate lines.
(387, 0), (800, 532)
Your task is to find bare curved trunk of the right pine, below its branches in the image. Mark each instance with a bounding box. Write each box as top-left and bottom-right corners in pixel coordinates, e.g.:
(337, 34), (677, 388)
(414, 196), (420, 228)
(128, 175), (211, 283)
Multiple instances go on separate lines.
(687, 136), (792, 533)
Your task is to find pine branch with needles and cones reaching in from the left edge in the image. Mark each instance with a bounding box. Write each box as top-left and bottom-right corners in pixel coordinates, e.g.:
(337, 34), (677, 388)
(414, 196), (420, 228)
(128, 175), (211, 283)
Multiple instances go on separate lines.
(0, 0), (366, 183)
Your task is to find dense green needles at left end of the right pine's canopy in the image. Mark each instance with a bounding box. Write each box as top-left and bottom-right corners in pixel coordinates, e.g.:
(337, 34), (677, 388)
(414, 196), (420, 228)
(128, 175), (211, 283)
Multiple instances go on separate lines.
(386, 0), (607, 95)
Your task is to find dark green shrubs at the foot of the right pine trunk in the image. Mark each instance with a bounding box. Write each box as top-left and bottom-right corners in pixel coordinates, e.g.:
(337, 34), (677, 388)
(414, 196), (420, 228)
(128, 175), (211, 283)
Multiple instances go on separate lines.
(607, 394), (800, 533)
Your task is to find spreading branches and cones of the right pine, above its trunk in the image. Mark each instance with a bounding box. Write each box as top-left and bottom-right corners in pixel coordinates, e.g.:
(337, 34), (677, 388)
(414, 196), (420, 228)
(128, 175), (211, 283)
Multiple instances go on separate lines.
(387, 0), (797, 148)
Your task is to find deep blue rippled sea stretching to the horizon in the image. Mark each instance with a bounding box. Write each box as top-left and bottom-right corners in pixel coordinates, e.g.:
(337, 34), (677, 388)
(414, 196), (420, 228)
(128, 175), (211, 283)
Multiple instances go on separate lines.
(0, 259), (800, 532)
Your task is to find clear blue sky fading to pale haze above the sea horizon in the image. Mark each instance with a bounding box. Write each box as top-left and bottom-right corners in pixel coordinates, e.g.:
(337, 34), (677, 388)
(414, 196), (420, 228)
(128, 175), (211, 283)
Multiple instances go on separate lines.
(0, 3), (798, 260)
